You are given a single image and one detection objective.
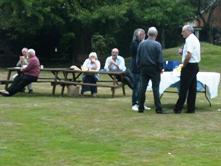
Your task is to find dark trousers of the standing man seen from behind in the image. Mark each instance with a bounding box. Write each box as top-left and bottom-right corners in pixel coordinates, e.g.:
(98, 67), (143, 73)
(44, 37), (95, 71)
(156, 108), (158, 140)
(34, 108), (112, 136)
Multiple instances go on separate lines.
(139, 66), (162, 111)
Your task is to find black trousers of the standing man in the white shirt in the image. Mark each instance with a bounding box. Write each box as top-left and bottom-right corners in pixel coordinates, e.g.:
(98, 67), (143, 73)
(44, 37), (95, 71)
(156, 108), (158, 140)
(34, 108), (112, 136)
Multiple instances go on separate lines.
(174, 63), (199, 113)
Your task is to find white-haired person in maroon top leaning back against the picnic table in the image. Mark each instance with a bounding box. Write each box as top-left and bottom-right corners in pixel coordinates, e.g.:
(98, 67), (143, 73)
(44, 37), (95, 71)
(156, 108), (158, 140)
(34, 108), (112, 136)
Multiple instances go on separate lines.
(0, 49), (40, 96)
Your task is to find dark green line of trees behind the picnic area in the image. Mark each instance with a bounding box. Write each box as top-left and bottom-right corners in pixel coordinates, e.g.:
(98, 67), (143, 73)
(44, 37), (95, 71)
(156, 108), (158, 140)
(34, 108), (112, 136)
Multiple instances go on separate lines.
(0, 0), (218, 64)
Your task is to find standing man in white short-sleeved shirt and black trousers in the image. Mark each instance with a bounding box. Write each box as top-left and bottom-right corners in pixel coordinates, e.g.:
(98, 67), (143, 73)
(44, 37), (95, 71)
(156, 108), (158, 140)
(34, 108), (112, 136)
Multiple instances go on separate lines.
(174, 25), (201, 114)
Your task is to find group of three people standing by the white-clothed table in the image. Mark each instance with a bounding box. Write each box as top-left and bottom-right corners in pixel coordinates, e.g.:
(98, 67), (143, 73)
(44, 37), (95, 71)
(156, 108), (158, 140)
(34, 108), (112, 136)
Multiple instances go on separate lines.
(130, 25), (200, 114)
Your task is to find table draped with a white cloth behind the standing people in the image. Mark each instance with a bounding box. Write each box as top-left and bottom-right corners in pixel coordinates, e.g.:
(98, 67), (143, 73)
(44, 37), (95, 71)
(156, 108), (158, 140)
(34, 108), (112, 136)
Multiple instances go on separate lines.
(147, 71), (220, 106)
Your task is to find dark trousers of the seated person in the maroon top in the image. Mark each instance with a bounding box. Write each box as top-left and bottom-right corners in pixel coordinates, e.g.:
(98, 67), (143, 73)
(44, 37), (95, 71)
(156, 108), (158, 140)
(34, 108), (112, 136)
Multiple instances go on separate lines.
(7, 74), (37, 96)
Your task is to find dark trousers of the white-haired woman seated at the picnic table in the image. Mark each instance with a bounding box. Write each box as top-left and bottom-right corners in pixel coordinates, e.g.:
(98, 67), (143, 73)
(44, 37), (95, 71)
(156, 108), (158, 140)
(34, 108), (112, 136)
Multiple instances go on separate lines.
(81, 75), (97, 94)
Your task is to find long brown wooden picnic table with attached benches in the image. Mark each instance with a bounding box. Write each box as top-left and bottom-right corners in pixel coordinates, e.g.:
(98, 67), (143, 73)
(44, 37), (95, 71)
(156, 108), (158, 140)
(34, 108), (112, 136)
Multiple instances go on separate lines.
(1, 67), (126, 97)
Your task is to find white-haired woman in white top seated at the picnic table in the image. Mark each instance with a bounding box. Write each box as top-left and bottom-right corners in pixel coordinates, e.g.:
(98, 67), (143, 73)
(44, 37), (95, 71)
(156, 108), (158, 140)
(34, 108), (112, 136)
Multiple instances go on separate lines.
(81, 52), (101, 97)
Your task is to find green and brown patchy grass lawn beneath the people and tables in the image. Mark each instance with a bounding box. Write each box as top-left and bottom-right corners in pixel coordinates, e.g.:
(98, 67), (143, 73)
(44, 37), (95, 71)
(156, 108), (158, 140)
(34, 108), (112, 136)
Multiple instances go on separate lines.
(0, 43), (221, 166)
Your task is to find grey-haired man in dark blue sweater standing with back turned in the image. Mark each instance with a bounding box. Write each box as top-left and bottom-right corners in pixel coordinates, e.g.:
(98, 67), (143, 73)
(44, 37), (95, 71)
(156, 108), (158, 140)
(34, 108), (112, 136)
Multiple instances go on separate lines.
(137, 27), (163, 114)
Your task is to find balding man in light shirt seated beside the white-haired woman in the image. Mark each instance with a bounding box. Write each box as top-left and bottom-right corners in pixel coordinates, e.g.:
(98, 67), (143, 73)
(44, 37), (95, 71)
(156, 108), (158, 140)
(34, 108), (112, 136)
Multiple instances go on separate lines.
(104, 48), (133, 89)
